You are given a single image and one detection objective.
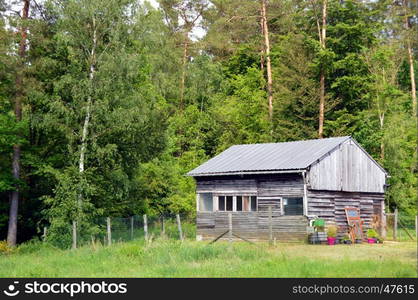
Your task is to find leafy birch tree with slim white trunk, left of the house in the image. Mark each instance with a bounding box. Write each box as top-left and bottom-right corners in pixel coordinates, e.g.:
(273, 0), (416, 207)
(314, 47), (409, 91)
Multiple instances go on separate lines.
(43, 0), (164, 232)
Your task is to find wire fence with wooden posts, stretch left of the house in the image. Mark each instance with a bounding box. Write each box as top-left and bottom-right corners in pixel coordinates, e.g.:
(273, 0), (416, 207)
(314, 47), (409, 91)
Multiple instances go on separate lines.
(43, 214), (196, 249)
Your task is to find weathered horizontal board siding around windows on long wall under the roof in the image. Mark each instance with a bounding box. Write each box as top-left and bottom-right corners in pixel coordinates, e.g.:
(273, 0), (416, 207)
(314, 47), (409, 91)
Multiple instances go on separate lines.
(196, 174), (308, 240)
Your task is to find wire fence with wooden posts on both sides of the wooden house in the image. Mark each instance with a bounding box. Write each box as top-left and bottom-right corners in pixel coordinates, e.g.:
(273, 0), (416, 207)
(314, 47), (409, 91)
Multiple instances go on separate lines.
(43, 210), (418, 248)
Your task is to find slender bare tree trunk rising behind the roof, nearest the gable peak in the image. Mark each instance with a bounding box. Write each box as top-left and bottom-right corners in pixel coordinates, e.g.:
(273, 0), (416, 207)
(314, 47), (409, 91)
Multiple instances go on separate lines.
(318, 0), (327, 138)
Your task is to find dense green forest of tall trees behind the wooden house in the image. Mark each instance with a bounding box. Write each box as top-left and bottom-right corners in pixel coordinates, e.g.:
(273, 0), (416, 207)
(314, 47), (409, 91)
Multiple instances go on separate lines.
(0, 0), (418, 246)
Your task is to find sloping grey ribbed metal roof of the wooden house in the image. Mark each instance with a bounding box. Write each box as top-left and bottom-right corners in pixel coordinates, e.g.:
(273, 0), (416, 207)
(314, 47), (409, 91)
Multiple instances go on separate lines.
(187, 136), (350, 176)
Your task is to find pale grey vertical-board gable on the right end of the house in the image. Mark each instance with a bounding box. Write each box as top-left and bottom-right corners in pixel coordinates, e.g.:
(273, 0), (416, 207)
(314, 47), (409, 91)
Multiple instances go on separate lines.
(307, 139), (386, 193)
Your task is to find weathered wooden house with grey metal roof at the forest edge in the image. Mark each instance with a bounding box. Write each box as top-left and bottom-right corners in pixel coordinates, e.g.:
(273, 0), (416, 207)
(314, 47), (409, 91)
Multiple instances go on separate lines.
(188, 136), (388, 240)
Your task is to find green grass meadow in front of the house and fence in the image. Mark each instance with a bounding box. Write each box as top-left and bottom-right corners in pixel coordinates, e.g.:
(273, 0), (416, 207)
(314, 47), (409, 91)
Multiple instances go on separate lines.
(0, 239), (417, 277)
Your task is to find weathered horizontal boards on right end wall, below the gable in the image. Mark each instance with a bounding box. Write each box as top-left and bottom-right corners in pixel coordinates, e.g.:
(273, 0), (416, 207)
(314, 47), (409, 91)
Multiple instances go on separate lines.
(308, 190), (384, 235)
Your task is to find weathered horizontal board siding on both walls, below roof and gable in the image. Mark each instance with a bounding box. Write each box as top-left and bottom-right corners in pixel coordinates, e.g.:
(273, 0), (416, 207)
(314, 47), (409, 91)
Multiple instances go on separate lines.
(197, 174), (384, 240)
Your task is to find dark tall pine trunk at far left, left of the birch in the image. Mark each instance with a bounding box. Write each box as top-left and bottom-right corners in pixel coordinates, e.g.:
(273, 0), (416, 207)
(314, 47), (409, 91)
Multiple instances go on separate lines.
(7, 0), (30, 247)
